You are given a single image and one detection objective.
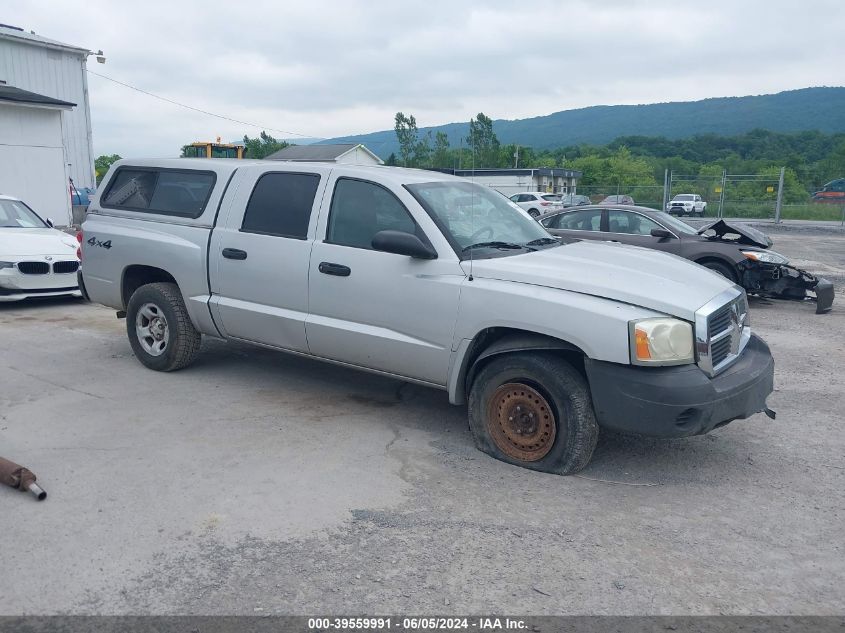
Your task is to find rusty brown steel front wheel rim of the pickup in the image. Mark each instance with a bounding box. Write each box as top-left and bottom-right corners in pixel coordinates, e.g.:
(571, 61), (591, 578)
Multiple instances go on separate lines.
(487, 383), (557, 462)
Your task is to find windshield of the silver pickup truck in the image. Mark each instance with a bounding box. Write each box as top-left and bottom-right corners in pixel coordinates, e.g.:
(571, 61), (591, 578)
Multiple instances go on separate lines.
(405, 181), (560, 258)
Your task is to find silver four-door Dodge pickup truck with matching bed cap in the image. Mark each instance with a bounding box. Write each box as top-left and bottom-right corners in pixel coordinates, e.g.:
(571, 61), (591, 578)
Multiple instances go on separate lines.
(79, 159), (774, 474)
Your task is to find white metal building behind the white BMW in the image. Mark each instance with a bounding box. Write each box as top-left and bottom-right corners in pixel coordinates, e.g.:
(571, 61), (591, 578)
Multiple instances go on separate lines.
(0, 26), (96, 224)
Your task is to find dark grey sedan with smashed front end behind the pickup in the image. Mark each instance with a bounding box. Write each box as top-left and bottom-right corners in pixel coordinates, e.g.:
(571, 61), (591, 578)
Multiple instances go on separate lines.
(538, 205), (834, 313)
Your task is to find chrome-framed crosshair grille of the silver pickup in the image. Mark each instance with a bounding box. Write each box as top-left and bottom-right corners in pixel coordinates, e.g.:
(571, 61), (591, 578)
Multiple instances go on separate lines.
(695, 287), (751, 376)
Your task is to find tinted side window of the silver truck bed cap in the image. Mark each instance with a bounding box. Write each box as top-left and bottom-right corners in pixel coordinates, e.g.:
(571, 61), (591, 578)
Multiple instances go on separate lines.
(101, 168), (217, 218)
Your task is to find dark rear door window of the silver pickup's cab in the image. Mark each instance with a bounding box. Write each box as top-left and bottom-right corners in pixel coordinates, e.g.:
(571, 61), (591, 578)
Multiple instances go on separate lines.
(241, 172), (320, 240)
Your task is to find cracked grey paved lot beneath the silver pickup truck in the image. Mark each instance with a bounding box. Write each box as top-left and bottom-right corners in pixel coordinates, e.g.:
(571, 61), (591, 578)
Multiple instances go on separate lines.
(0, 234), (845, 614)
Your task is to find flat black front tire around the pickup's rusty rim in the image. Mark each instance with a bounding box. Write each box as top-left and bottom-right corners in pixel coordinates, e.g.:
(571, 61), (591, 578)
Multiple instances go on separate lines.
(469, 353), (599, 475)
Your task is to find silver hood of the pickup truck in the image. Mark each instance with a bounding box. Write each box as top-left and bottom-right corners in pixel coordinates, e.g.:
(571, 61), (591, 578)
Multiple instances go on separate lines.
(461, 240), (733, 321)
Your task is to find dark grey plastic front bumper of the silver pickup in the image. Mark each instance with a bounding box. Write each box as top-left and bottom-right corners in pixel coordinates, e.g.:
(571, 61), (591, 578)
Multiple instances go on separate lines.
(585, 334), (775, 438)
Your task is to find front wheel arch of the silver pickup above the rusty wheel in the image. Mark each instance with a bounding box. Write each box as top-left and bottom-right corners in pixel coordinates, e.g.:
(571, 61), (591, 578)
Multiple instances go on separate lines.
(449, 327), (586, 404)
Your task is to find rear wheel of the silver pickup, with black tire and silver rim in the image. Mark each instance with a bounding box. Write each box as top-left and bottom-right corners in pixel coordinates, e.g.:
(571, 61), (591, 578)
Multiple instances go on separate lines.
(126, 282), (202, 371)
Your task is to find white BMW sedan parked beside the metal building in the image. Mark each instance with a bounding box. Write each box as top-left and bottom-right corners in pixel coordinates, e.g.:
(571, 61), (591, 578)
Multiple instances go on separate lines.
(0, 196), (82, 301)
